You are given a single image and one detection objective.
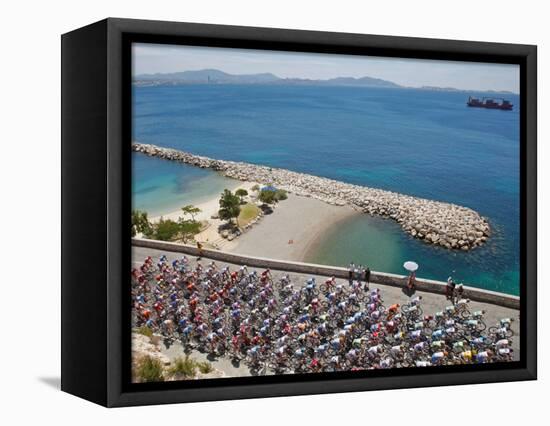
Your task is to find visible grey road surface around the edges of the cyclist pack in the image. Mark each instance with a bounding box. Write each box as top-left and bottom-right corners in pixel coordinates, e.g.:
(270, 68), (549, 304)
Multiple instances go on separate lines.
(132, 247), (520, 376)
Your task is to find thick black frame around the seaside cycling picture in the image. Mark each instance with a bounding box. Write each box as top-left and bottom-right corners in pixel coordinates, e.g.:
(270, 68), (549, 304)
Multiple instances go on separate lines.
(61, 18), (537, 407)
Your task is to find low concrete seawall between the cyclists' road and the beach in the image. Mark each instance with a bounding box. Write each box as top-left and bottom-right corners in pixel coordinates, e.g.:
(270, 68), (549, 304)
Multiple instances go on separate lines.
(132, 238), (520, 309)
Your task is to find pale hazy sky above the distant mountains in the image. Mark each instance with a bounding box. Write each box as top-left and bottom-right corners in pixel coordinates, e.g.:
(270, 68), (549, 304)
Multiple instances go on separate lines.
(133, 43), (519, 93)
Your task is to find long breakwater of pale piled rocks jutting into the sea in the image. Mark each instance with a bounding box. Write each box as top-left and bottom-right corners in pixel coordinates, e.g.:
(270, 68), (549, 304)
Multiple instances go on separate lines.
(133, 143), (491, 251)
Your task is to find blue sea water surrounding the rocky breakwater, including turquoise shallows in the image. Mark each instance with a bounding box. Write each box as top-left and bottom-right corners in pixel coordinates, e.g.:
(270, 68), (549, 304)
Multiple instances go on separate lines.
(133, 85), (519, 294)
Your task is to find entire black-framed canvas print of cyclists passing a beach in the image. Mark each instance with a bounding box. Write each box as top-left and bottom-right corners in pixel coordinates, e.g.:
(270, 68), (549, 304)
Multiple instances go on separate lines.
(62, 19), (536, 406)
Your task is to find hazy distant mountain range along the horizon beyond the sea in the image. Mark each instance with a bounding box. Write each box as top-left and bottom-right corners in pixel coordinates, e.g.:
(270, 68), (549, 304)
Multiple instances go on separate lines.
(133, 69), (512, 94)
